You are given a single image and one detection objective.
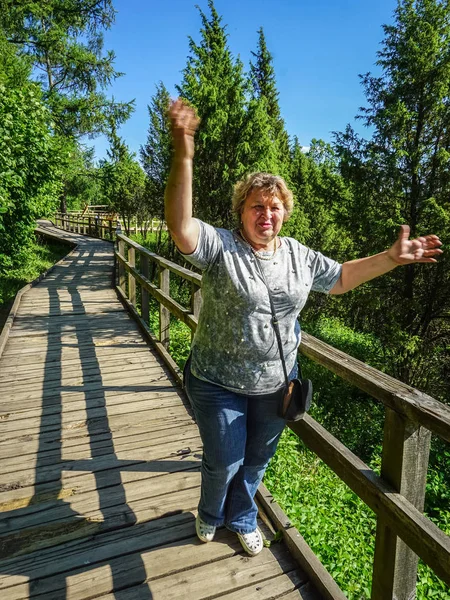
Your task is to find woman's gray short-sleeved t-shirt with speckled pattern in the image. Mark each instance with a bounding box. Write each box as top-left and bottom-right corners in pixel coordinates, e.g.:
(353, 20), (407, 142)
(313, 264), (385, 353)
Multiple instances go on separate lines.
(184, 220), (341, 395)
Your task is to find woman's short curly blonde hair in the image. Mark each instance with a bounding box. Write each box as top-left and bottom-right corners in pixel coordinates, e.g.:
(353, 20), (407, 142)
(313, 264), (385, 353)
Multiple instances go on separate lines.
(232, 173), (294, 221)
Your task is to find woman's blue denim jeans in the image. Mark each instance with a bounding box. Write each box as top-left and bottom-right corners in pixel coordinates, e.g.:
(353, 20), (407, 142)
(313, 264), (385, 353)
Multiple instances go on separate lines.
(185, 364), (297, 533)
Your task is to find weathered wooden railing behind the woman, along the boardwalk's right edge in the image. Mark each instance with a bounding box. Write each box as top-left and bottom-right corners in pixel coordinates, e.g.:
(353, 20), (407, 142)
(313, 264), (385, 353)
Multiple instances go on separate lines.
(115, 234), (450, 600)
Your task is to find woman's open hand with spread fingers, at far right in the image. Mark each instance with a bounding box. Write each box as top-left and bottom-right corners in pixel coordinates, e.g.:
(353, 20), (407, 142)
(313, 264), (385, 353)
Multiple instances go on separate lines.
(387, 225), (442, 265)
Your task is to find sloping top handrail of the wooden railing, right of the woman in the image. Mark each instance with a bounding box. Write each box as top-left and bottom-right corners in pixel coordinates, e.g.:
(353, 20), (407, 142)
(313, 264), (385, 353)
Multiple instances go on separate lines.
(300, 333), (450, 442)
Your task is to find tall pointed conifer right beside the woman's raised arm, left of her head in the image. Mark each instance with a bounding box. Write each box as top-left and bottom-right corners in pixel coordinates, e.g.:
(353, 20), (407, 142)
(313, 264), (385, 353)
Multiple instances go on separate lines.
(178, 0), (250, 227)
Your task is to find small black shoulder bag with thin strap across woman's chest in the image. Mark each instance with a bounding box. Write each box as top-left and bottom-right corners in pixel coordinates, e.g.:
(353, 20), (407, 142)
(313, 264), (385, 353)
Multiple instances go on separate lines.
(256, 260), (312, 421)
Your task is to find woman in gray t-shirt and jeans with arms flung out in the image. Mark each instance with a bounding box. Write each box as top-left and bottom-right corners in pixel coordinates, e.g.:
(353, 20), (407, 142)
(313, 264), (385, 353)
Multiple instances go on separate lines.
(166, 100), (442, 556)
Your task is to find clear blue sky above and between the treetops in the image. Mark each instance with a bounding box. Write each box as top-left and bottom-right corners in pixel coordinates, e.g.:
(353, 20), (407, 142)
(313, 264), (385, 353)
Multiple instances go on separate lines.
(88, 0), (397, 158)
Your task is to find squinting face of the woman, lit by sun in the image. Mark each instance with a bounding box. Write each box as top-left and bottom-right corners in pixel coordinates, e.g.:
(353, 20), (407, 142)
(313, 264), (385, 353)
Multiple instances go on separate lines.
(241, 189), (284, 249)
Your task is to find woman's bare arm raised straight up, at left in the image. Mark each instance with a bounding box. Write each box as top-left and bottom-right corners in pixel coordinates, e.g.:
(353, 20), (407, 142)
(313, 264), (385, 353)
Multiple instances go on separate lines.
(165, 99), (199, 254)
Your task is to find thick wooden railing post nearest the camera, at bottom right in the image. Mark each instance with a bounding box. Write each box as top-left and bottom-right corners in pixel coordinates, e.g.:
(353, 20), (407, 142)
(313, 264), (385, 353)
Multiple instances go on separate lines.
(371, 407), (431, 600)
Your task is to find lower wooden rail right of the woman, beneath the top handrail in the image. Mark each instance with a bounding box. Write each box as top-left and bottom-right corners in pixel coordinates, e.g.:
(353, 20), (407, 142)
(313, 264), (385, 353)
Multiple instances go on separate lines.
(289, 415), (450, 584)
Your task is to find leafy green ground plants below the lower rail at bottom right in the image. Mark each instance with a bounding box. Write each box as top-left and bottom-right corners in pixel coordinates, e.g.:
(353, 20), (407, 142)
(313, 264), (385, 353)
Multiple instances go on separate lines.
(264, 429), (450, 600)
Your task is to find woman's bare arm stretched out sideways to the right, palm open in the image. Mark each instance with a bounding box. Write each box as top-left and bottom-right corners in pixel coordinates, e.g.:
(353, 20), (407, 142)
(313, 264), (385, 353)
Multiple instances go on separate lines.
(330, 225), (442, 294)
